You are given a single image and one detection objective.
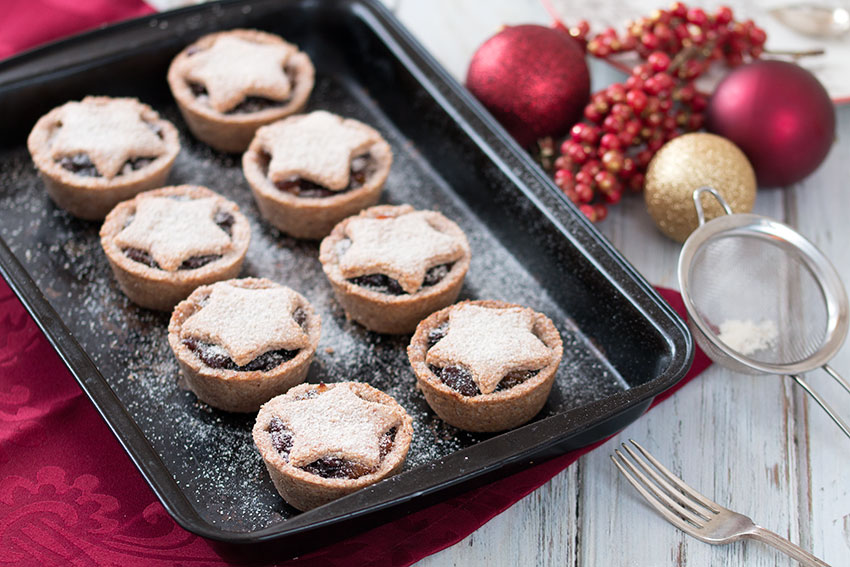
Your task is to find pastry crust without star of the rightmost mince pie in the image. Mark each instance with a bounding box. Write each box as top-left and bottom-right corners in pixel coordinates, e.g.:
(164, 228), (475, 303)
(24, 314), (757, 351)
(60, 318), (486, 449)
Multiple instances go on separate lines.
(407, 300), (564, 432)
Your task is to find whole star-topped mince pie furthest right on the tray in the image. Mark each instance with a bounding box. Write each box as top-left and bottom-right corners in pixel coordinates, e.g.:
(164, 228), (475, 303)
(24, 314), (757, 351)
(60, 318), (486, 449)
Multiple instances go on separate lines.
(407, 300), (564, 432)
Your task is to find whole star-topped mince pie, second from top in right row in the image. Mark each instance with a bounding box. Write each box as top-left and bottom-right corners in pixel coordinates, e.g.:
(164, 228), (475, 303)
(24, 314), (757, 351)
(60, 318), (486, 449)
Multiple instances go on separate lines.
(242, 110), (392, 239)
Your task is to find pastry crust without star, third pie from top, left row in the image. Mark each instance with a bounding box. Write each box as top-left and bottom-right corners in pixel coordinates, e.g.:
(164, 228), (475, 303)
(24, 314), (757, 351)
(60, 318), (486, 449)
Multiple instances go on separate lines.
(168, 278), (322, 412)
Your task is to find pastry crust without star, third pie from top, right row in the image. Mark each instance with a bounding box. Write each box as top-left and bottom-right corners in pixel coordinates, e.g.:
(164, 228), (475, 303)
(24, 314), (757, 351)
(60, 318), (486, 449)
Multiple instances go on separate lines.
(319, 205), (471, 334)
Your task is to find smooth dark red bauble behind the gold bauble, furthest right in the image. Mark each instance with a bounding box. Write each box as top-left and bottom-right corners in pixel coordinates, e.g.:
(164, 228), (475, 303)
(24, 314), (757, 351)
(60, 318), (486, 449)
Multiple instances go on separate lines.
(706, 61), (835, 187)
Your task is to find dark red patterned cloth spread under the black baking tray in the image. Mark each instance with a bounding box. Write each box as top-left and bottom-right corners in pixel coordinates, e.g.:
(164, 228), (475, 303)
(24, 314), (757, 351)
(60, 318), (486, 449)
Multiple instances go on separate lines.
(0, 0), (709, 567)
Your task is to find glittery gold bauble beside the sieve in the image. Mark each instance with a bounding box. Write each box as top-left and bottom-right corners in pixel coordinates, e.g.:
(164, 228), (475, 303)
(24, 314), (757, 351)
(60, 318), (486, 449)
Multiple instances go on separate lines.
(644, 133), (756, 242)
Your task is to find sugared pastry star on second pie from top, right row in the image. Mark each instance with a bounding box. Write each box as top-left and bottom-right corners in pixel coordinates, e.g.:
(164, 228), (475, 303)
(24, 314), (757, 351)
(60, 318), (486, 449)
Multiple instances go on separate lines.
(258, 110), (380, 191)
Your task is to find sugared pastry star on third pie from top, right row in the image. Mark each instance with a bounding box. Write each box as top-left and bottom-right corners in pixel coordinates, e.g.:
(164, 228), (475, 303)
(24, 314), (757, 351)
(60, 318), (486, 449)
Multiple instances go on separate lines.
(339, 211), (464, 293)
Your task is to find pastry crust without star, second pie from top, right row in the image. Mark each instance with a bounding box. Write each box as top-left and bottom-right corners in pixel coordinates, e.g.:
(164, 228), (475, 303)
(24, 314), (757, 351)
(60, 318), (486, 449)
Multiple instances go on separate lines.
(242, 115), (393, 240)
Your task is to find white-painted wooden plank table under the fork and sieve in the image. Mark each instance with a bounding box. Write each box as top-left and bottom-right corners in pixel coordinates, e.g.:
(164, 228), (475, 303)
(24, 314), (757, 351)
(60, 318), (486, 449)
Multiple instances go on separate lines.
(151, 0), (850, 567)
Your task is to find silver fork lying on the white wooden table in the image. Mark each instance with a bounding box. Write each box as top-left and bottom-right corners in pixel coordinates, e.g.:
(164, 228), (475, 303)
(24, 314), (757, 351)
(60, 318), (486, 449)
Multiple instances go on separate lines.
(611, 439), (829, 567)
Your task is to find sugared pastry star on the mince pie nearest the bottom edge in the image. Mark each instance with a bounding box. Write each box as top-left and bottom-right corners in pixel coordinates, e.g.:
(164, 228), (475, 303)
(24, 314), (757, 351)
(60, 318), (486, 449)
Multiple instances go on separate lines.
(278, 384), (401, 468)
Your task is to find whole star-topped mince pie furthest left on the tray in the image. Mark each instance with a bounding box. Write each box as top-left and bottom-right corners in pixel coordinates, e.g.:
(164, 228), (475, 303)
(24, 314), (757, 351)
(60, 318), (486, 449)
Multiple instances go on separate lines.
(27, 96), (180, 220)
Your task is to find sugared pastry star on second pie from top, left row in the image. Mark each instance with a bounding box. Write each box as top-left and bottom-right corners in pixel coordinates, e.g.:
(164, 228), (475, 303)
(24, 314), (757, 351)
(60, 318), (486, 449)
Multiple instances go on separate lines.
(115, 197), (232, 272)
